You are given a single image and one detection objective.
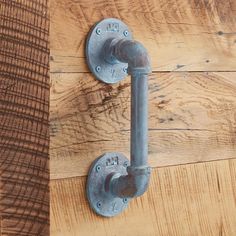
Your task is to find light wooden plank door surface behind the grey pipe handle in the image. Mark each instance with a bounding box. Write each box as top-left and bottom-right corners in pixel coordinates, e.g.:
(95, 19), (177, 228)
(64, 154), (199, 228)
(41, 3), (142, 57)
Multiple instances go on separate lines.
(50, 0), (236, 236)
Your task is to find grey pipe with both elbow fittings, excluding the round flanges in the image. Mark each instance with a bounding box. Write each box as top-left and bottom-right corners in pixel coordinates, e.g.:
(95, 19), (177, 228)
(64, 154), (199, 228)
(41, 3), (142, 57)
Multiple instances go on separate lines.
(104, 38), (151, 198)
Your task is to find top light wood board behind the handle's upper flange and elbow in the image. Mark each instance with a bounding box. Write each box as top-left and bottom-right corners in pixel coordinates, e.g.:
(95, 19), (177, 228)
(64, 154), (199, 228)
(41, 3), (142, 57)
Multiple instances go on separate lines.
(50, 0), (236, 72)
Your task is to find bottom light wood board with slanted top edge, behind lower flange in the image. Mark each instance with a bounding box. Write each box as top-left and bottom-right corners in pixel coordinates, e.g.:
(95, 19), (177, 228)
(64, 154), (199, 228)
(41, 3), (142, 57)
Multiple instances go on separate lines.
(50, 159), (236, 236)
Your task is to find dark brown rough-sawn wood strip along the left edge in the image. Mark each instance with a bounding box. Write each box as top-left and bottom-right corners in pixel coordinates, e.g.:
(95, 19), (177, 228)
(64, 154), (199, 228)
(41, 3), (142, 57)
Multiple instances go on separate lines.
(0, 0), (49, 236)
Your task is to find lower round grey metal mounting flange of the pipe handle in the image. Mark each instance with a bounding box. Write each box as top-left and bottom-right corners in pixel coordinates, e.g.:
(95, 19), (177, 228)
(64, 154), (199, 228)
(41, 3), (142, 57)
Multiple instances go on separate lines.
(86, 153), (130, 217)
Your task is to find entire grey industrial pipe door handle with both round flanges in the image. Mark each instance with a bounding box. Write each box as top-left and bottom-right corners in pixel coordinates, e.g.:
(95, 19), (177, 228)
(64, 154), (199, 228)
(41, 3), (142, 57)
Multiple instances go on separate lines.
(86, 18), (151, 217)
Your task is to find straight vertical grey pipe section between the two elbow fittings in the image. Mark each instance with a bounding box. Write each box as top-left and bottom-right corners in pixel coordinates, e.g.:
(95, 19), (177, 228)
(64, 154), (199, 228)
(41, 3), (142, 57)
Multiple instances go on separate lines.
(131, 73), (148, 167)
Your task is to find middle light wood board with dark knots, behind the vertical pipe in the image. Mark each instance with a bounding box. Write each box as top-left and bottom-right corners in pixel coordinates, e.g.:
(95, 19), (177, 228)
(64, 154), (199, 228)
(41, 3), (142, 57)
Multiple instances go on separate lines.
(50, 72), (236, 179)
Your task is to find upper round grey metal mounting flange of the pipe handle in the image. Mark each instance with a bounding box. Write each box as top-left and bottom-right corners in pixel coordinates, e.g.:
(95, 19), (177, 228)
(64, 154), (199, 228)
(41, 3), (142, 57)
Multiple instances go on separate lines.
(86, 18), (132, 84)
